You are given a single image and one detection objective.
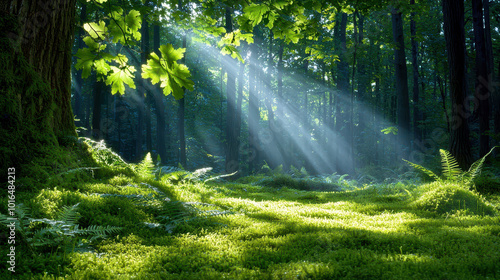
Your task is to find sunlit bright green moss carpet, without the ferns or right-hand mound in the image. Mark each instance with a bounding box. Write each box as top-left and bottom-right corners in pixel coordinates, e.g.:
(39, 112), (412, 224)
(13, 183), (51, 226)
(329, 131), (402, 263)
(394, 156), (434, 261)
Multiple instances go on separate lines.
(6, 167), (500, 279)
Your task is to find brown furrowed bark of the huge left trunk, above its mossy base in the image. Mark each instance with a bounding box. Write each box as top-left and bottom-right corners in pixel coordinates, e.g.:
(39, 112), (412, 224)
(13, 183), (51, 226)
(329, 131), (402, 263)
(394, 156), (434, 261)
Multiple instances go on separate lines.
(2, 0), (76, 137)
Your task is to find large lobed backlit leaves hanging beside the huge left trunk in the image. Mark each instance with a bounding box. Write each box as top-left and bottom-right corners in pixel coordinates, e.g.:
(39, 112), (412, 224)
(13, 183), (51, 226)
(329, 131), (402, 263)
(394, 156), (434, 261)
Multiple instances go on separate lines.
(75, 6), (194, 99)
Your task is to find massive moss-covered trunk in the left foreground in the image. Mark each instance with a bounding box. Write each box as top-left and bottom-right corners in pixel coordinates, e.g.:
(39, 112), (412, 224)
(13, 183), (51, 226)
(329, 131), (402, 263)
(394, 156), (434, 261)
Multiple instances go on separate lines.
(0, 0), (76, 170)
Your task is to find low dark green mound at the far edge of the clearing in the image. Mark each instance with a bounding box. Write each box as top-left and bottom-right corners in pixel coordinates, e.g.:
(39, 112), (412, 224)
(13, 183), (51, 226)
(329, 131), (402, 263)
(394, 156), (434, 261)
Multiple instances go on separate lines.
(254, 175), (342, 191)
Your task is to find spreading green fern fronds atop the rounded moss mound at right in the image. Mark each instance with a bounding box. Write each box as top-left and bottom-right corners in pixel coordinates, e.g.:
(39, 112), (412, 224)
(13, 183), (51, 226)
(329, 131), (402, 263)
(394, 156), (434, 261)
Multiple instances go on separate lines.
(403, 147), (496, 185)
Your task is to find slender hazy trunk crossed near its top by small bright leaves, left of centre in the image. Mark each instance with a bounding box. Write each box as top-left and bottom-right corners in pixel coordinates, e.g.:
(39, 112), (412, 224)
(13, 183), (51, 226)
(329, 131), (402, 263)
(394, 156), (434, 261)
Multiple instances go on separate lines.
(225, 7), (240, 174)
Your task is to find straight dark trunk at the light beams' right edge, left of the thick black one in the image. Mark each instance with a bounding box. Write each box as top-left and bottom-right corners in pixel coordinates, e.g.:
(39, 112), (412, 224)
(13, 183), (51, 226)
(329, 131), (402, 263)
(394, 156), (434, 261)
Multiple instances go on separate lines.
(392, 9), (410, 158)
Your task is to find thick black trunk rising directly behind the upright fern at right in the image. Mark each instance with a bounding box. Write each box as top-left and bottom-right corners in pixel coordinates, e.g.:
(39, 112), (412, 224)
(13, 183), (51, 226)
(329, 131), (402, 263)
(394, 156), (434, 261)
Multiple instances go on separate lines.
(442, 0), (472, 169)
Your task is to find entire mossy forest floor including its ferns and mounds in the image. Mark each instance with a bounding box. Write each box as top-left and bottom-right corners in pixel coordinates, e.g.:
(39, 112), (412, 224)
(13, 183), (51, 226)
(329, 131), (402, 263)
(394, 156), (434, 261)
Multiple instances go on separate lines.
(0, 139), (500, 279)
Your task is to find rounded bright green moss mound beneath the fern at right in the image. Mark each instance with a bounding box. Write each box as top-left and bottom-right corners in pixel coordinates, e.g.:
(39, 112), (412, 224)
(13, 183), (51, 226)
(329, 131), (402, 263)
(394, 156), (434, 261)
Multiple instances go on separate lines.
(413, 182), (494, 215)
